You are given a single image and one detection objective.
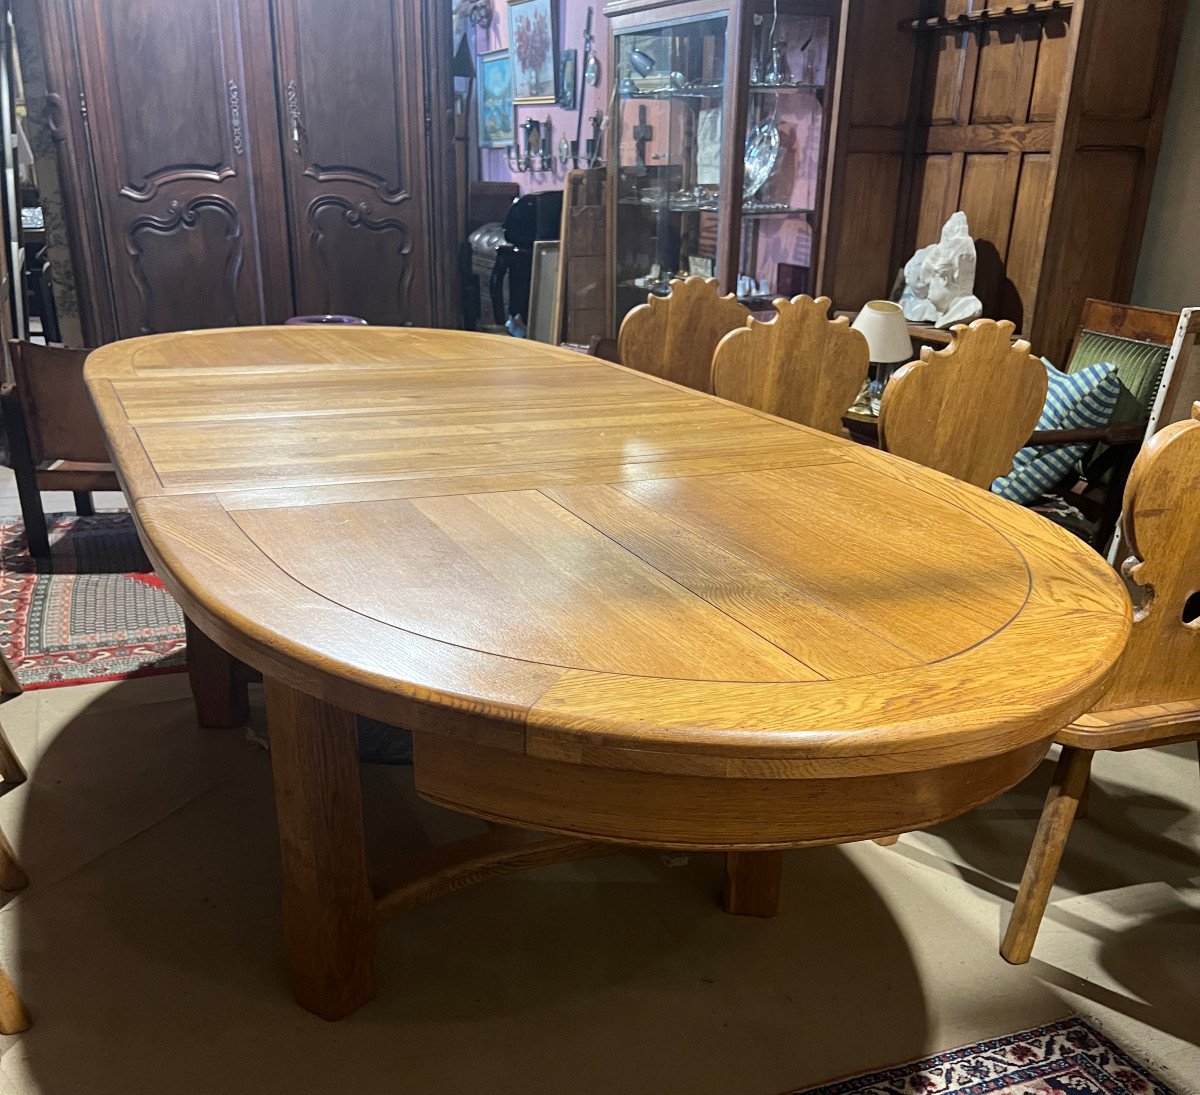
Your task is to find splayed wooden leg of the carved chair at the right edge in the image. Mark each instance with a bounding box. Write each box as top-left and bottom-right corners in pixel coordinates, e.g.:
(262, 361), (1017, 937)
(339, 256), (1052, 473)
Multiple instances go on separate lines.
(1000, 747), (1093, 965)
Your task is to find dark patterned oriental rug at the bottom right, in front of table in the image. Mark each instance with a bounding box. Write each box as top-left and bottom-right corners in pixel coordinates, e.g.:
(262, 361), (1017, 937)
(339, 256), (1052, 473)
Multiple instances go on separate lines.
(791, 1019), (1172, 1095)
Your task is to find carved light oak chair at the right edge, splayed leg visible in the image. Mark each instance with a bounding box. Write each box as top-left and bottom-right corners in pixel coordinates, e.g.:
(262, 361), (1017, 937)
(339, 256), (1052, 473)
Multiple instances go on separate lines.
(1000, 403), (1200, 963)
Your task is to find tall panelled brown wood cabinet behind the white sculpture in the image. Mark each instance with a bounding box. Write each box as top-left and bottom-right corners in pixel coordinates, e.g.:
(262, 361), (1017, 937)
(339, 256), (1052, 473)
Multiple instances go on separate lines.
(817, 0), (1190, 363)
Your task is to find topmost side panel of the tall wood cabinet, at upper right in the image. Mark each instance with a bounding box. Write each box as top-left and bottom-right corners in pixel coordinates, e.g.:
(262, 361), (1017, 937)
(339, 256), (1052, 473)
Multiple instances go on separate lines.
(1081, 0), (1166, 118)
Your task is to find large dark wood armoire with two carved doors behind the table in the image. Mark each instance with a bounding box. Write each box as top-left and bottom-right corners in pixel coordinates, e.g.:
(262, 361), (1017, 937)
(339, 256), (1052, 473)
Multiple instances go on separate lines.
(38, 0), (456, 345)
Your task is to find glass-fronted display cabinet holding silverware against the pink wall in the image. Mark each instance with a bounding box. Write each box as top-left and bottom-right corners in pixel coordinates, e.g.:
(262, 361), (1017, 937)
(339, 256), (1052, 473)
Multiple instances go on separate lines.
(605, 0), (841, 327)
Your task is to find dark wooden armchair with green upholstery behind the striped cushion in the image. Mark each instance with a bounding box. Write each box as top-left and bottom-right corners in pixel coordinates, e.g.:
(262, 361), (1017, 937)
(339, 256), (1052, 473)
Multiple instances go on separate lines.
(1030, 299), (1180, 551)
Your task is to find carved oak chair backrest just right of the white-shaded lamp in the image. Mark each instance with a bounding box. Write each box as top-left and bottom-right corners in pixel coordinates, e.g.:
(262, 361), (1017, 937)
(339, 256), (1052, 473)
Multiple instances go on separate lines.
(880, 319), (1046, 490)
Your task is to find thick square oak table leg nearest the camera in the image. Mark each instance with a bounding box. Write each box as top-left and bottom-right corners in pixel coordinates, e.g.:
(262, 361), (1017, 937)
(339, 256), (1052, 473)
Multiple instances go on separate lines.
(266, 680), (376, 1019)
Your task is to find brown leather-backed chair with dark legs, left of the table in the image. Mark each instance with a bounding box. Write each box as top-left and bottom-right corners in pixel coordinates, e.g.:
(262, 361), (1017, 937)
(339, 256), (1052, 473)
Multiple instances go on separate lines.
(0, 339), (121, 558)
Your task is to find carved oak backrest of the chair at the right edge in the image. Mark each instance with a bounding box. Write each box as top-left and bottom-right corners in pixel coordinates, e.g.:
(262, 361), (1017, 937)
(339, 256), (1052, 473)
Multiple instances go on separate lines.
(1094, 403), (1200, 711)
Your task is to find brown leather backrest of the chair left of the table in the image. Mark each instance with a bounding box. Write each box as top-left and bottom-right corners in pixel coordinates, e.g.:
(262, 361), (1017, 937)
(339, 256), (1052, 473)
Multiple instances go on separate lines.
(8, 339), (108, 463)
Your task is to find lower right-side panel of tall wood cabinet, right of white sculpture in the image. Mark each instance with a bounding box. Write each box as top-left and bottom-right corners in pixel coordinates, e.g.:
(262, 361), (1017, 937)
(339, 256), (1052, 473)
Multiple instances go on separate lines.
(1032, 149), (1144, 361)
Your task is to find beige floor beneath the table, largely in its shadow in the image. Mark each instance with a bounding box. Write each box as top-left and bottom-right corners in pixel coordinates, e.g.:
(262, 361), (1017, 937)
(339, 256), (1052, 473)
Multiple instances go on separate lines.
(0, 490), (1200, 1095)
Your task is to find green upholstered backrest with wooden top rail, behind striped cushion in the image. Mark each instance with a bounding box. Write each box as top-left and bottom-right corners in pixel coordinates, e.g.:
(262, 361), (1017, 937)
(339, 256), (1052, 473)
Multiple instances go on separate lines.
(1067, 298), (1180, 423)
